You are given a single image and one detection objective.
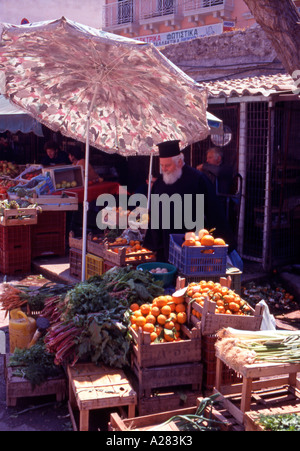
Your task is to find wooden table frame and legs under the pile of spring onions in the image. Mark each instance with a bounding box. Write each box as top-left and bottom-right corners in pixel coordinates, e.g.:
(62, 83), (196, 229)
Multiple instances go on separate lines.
(215, 353), (300, 424)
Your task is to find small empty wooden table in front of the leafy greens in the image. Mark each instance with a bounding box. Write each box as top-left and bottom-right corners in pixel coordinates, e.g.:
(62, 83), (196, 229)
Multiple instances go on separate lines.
(67, 363), (137, 431)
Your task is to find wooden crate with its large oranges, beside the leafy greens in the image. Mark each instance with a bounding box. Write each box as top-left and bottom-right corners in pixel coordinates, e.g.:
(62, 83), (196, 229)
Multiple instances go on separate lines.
(130, 293), (201, 368)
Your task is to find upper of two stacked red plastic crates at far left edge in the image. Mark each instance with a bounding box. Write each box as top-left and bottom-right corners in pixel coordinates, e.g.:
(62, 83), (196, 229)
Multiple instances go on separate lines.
(0, 225), (30, 252)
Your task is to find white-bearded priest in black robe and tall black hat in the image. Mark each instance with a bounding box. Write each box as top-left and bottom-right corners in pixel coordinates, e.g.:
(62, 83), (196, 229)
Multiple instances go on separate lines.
(144, 140), (235, 262)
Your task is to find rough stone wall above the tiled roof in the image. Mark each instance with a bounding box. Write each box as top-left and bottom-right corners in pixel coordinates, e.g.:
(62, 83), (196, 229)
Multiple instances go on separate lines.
(160, 25), (283, 81)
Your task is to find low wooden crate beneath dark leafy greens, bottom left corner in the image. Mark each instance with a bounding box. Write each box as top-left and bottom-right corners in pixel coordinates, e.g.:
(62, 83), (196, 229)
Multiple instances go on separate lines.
(5, 355), (67, 407)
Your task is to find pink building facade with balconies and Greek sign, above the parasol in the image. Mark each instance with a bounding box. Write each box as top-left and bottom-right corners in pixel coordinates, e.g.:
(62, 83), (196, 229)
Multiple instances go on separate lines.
(102, 0), (255, 46)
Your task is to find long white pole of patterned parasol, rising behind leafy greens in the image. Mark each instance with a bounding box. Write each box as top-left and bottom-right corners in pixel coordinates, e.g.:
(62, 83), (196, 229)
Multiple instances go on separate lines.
(81, 85), (98, 282)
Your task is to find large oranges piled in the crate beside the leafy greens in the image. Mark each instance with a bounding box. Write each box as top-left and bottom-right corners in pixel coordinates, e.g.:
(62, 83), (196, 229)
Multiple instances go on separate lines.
(130, 295), (187, 343)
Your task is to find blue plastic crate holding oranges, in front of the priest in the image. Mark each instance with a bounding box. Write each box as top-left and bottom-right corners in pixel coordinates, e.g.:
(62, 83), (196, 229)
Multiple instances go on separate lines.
(169, 234), (228, 276)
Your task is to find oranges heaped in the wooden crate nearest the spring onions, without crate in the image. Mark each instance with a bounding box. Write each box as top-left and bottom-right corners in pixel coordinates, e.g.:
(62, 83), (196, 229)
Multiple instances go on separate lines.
(186, 280), (251, 318)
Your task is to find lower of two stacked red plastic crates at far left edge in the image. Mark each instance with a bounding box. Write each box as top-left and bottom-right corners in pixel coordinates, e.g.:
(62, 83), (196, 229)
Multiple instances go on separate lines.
(0, 246), (31, 276)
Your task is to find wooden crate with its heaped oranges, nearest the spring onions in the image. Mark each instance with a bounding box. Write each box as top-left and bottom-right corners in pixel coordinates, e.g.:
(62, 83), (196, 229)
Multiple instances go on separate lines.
(186, 280), (263, 335)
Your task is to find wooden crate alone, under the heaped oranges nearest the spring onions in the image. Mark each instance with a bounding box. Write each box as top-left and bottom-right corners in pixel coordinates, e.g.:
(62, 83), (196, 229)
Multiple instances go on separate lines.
(188, 300), (264, 335)
